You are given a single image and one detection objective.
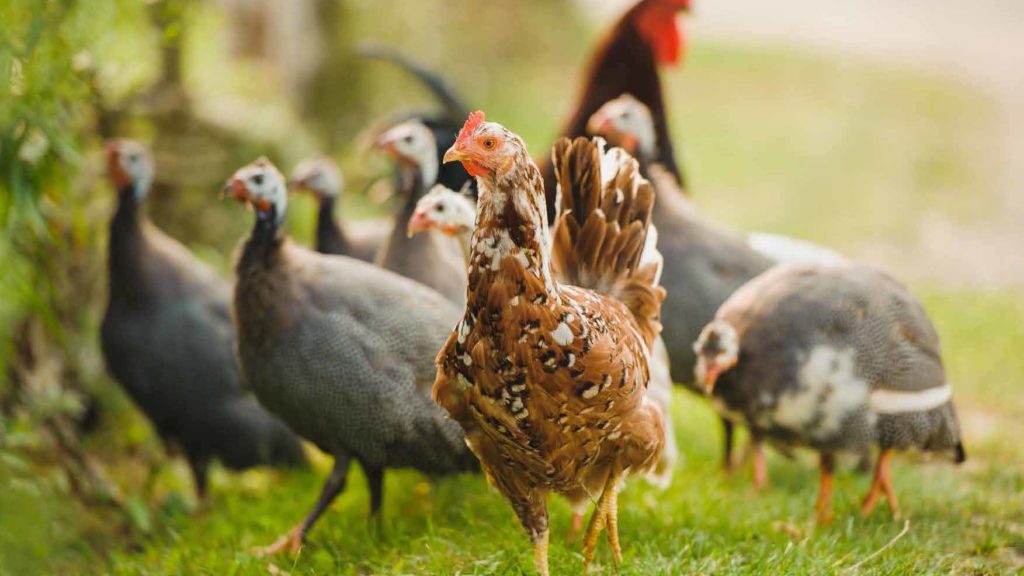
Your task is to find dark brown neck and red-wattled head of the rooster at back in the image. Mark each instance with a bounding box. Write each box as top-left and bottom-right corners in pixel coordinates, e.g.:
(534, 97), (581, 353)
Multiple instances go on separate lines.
(540, 0), (690, 222)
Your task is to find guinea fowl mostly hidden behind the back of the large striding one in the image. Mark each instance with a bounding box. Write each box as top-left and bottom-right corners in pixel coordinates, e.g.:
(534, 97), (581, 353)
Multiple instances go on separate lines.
(289, 158), (390, 258)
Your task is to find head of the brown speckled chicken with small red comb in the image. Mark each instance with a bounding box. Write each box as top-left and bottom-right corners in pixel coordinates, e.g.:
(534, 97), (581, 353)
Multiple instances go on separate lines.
(444, 111), (528, 178)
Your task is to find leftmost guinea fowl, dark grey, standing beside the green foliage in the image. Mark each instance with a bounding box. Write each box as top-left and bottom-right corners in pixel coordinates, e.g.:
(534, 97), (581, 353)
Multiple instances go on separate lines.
(100, 140), (305, 497)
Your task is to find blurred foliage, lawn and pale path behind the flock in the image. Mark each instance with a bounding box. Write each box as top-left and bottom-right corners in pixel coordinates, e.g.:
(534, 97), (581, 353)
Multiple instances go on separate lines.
(0, 0), (1024, 574)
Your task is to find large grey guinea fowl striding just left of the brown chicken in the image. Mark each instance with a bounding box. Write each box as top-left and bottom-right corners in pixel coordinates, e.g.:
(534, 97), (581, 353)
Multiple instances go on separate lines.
(225, 159), (478, 553)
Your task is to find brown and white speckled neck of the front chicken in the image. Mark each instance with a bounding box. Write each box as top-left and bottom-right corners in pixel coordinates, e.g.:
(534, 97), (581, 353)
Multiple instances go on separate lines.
(466, 154), (557, 307)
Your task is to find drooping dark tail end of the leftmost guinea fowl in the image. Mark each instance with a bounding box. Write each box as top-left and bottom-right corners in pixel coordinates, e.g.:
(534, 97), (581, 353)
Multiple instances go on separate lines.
(205, 397), (308, 469)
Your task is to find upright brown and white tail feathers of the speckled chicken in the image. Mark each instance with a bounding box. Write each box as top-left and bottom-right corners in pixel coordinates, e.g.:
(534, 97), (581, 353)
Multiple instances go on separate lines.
(551, 137), (665, 345)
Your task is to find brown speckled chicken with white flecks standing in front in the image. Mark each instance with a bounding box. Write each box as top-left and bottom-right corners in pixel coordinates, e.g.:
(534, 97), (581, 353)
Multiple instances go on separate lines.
(433, 112), (665, 574)
